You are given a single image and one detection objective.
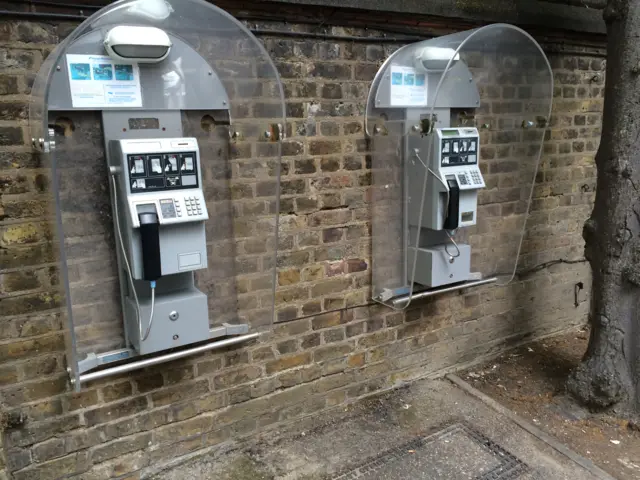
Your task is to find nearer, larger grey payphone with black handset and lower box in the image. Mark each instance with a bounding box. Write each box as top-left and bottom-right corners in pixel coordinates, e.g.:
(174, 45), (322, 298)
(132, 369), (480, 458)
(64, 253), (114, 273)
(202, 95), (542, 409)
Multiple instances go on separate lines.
(108, 138), (209, 355)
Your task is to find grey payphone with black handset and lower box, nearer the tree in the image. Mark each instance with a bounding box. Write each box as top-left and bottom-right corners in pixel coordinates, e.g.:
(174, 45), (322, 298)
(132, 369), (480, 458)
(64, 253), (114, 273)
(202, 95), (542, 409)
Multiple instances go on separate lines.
(408, 124), (485, 287)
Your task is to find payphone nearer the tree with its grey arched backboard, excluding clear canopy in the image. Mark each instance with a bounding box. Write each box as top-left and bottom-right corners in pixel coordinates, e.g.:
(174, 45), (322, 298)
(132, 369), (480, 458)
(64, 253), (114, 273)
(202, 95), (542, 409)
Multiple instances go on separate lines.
(374, 46), (485, 298)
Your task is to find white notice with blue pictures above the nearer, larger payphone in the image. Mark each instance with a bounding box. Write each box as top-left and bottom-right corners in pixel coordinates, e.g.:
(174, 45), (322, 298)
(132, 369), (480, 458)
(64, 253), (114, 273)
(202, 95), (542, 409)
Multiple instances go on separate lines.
(67, 55), (142, 108)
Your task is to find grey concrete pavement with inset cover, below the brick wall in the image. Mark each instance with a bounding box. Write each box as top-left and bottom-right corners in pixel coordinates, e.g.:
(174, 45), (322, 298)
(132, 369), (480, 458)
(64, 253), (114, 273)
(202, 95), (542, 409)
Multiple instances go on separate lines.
(154, 379), (602, 480)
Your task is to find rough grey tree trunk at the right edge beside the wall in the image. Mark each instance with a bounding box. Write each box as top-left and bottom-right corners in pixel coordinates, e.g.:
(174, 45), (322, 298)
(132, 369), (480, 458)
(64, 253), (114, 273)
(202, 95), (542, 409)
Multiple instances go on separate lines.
(568, 0), (640, 410)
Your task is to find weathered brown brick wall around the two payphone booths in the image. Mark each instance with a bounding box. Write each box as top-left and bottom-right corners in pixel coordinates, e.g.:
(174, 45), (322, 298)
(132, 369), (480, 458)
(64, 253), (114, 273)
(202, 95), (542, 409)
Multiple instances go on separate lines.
(0, 11), (604, 480)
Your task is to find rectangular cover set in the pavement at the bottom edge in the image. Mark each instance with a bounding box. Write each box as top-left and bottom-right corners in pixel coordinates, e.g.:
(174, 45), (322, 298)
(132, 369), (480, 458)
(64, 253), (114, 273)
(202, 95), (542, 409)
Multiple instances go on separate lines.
(333, 423), (528, 480)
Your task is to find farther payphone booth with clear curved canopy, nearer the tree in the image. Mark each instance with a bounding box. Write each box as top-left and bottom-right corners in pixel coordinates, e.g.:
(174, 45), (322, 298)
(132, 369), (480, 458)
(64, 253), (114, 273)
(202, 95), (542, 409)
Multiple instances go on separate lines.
(365, 24), (553, 308)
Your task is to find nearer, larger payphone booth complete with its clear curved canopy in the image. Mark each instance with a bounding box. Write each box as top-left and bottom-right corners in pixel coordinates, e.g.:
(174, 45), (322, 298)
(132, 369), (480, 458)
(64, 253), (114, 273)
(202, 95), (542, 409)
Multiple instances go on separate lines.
(29, 0), (286, 389)
